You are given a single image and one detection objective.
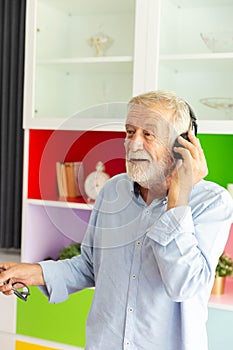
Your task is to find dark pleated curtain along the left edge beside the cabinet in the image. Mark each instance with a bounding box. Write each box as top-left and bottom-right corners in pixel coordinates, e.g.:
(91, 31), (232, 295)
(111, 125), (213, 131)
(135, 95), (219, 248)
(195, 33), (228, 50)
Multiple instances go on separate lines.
(0, 0), (26, 249)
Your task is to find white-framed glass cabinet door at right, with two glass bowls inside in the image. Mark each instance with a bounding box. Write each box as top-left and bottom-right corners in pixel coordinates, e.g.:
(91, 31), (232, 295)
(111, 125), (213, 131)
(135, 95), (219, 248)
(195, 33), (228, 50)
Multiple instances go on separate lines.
(157, 0), (233, 133)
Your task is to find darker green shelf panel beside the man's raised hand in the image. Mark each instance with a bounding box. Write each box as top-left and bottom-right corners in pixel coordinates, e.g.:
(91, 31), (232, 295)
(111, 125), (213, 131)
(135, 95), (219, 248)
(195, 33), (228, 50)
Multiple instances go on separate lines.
(198, 134), (233, 187)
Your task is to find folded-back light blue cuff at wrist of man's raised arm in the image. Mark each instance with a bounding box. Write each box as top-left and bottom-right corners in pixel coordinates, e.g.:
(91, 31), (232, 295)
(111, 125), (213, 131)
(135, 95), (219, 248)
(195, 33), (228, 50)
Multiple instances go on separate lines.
(147, 206), (194, 246)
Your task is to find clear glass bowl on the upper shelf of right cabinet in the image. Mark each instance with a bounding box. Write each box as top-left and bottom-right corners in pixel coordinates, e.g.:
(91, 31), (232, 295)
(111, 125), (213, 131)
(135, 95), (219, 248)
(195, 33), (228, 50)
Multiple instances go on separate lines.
(200, 32), (233, 52)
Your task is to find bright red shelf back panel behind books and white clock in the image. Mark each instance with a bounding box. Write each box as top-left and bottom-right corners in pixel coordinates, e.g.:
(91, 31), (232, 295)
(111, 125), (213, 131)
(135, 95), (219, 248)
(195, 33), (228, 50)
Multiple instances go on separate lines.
(28, 130), (125, 202)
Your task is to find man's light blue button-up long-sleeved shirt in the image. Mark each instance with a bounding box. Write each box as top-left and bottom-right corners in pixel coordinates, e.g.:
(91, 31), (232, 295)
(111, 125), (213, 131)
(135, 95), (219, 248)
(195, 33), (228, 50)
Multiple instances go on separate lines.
(40, 174), (233, 350)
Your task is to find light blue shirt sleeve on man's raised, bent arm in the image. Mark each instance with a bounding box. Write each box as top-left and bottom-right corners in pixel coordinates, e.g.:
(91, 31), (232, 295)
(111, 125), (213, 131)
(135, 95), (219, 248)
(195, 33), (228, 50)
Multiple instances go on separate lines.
(147, 185), (233, 301)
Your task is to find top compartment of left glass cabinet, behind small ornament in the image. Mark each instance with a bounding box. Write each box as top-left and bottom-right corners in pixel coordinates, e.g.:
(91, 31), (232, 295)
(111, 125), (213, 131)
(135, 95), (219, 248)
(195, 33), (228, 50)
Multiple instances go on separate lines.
(36, 0), (135, 58)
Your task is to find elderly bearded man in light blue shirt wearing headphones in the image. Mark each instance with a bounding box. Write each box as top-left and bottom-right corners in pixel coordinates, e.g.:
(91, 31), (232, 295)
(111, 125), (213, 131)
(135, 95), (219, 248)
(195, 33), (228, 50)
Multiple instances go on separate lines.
(0, 91), (233, 350)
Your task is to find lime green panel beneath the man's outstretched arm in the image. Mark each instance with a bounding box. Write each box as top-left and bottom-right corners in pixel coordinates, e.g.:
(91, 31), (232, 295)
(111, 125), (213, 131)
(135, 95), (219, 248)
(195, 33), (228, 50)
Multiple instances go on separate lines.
(16, 287), (94, 348)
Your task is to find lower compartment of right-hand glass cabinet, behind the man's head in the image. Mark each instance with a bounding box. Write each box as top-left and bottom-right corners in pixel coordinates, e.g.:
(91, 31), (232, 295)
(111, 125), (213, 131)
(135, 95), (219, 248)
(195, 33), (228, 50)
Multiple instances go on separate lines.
(158, 56), (233, 121)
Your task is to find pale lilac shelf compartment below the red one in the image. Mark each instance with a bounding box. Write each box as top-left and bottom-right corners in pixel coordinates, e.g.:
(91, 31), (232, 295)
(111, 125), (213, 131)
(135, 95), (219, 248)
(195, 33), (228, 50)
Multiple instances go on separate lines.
(22, 203), (91, 262)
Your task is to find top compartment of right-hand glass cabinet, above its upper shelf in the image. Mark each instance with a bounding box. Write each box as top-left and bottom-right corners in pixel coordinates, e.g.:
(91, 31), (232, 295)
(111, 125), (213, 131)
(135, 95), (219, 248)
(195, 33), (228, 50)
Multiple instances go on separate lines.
(160, 0), (233, 54)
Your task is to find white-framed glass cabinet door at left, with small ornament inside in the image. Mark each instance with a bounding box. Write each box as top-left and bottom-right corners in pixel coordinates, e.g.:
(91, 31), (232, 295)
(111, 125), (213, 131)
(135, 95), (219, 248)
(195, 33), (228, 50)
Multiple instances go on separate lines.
(24, 0), (159, 129)
